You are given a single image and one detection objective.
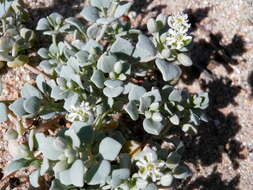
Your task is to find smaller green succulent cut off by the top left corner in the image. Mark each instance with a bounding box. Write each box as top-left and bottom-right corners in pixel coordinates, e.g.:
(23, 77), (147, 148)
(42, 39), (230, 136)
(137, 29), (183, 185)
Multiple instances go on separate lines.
(0, 0), (35, 69)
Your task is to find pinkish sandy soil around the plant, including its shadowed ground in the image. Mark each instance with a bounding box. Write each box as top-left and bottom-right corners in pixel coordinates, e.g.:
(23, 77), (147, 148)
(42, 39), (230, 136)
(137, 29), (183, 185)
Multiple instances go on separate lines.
(0, 0), (253, 190)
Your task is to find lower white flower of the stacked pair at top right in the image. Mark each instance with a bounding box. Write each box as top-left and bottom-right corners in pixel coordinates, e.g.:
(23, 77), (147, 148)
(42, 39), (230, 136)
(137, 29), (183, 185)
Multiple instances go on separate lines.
(166, 29), (192, 50)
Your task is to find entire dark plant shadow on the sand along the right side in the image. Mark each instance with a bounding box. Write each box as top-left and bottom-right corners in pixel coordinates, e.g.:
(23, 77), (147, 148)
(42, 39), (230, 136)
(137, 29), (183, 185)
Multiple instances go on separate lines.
(179, 8), (246, 190)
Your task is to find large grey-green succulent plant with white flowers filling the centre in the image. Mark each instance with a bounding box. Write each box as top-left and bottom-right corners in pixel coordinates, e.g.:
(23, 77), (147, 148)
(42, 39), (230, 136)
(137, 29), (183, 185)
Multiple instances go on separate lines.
(0, 0), (209, 190)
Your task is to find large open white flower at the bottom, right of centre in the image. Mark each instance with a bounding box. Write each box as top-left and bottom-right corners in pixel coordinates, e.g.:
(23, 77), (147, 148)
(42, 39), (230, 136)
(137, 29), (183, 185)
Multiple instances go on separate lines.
(135, 147), (164, 182)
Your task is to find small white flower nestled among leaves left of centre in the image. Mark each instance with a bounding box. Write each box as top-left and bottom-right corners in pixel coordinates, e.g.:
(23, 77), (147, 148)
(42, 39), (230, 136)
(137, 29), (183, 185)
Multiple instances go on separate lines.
(66, 102), (94, 124)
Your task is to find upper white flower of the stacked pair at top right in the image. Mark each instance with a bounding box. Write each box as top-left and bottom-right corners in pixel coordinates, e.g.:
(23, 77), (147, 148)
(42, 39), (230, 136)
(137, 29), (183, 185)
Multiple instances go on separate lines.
(168, 13), (191, 33)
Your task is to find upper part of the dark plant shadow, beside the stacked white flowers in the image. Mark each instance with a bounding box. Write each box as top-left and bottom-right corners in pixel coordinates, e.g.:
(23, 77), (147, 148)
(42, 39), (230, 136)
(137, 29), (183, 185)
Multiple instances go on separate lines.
(183, 7), (246, 84)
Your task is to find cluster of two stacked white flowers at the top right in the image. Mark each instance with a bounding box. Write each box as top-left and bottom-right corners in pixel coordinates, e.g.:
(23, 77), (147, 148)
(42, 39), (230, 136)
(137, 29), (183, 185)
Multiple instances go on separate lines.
(166, 14), (192, 50)
